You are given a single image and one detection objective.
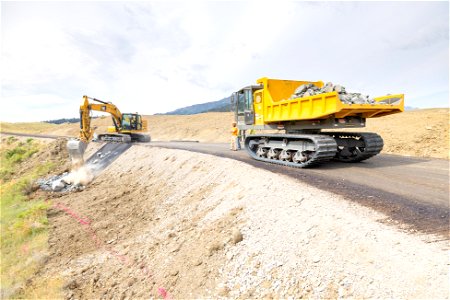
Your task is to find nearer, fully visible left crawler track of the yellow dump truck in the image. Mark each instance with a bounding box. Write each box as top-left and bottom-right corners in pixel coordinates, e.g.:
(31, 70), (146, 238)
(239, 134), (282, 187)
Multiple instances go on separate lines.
(245, 134), (337, 168)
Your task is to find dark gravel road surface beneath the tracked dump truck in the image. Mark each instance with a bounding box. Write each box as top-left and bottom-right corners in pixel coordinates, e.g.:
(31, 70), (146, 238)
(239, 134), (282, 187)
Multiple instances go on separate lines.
(145, 142), (450, 239)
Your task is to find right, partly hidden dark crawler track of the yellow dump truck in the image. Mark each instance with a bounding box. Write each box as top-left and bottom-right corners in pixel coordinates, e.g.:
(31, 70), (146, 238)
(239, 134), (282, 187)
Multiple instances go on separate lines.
(321, 132), (384, 162)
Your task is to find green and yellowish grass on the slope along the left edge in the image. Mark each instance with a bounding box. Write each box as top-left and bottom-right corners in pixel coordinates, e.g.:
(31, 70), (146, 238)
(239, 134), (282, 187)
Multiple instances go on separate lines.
(0, 137), (60, 299)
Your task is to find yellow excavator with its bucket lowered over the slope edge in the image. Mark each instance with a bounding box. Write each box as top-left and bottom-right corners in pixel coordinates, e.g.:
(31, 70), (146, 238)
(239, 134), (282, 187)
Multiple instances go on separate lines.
(67, 96), (150, 161)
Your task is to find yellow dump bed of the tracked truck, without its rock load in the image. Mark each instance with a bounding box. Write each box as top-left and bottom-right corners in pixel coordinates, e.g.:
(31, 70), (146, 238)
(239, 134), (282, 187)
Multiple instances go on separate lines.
(258, 78), (404, 123)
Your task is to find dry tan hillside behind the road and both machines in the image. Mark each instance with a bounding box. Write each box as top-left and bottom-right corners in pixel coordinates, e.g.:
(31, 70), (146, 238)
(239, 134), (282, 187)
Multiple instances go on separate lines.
(2, 108), (450, 159)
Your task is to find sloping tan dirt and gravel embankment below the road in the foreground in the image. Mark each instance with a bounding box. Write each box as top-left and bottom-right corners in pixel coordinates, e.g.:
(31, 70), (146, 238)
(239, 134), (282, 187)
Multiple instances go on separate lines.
(40, 146), (449, 299)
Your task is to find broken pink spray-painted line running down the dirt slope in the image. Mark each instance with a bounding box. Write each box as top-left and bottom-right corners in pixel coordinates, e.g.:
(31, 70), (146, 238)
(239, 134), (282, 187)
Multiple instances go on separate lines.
(54, 203), (170, 300)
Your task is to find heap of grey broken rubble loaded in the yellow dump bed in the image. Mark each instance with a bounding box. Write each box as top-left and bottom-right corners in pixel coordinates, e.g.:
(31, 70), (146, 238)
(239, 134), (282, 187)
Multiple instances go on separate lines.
(289, 82), (375, 104)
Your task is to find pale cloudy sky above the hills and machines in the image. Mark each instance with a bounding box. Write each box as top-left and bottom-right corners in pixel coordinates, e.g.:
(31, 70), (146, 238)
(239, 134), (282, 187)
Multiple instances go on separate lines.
(0, 1), (449, 121)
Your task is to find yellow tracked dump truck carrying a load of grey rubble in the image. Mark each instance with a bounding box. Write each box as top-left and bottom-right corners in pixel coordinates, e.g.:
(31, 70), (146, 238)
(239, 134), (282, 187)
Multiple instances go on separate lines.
(231, 77), (404, 168)
